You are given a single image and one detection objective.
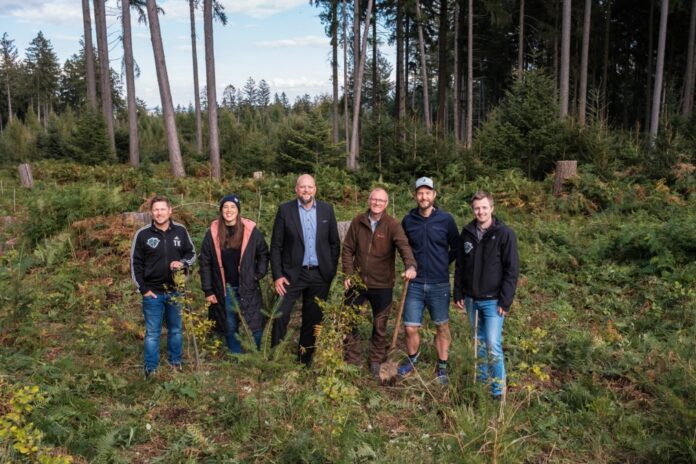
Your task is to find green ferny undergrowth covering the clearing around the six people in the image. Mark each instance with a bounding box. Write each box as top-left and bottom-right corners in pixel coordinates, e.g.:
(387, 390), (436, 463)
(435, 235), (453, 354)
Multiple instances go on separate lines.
(0, 162), (696, 463)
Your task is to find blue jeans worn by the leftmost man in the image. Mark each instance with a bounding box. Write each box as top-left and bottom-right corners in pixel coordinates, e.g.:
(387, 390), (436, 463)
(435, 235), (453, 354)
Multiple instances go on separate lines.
(143, 292), (183, 371)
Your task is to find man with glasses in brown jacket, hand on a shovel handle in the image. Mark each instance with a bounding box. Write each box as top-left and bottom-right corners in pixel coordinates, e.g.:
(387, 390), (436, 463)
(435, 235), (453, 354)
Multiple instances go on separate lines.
(341, 188), (416, 378)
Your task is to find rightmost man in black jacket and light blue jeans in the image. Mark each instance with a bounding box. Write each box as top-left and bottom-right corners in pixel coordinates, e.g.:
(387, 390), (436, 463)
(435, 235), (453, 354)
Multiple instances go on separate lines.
(454, 192), (520, 398)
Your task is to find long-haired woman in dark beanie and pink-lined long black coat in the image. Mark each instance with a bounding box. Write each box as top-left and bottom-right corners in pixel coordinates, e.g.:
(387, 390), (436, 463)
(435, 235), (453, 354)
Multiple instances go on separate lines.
(200, 195), (268, 353)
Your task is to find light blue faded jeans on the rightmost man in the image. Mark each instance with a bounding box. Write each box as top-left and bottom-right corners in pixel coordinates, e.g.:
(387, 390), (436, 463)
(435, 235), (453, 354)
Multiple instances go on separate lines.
(466, 298), (506, 396)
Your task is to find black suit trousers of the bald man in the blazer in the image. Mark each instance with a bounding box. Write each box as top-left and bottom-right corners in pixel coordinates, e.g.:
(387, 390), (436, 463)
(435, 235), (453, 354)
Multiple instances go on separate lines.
(271, 268), (331, 364)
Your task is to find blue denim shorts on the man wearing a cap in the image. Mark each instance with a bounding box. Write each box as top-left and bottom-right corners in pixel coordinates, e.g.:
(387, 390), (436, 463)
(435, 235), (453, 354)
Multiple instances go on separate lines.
(404, 282), (450, 327)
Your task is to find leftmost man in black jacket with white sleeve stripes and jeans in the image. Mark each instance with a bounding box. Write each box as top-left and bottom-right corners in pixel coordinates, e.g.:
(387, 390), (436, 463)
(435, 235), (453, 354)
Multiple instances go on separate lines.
(131, 196), (196, 377)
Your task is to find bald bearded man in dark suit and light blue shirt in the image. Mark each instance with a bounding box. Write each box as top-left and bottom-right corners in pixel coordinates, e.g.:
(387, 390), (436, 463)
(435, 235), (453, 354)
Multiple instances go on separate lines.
(271, 174), (340, 364)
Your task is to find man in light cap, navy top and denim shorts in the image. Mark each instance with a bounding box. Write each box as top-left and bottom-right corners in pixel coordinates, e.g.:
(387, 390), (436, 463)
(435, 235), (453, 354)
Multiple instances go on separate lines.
(397, 177), (459, 384)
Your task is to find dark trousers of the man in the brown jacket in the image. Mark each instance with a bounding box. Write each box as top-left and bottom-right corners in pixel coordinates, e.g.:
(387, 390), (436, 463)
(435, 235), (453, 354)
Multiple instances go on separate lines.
(343, 288), (394, 364)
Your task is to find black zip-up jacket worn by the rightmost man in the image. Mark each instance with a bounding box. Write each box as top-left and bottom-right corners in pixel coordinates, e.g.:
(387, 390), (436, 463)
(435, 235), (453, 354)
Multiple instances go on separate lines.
(454, 217), (520, 311)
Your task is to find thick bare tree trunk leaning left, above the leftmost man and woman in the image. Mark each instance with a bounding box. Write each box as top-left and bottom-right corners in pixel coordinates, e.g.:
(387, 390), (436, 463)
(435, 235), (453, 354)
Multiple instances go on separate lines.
(147, 0), (186, 177)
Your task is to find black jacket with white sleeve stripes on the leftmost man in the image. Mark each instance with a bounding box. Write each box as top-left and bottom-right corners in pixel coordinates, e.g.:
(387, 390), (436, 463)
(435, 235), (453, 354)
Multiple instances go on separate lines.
(131, 220), (196, 295)
